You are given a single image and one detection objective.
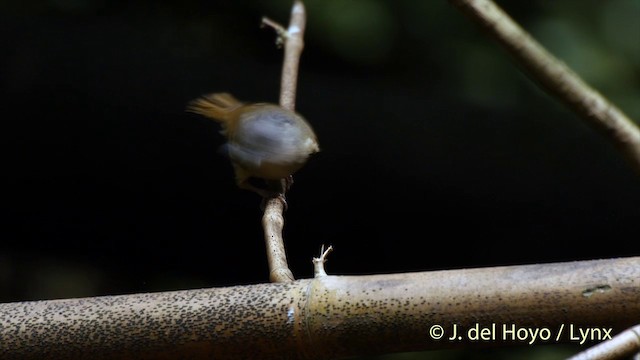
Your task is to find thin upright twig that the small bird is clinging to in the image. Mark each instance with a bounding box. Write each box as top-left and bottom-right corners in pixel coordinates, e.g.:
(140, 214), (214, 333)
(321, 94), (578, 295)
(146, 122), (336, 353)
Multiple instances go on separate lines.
(262, 0), (306, 282)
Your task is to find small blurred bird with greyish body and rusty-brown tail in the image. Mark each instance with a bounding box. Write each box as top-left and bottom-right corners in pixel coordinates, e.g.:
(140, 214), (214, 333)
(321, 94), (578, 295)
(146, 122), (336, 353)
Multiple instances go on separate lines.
(187, 93), (320, 198)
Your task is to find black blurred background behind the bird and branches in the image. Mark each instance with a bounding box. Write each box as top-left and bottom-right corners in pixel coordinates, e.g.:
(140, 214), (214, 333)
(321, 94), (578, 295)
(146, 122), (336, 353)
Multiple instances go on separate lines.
(0, 0), (640, 334)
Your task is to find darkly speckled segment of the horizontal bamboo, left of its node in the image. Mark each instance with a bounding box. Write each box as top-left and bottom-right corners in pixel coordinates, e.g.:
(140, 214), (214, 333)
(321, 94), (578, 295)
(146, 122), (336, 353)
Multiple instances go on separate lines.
(0, 283), (312, 359)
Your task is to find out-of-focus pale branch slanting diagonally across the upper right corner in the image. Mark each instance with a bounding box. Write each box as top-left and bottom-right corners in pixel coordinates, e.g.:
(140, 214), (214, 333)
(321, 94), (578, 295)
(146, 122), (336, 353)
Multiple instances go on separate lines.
(450, 0), (640, 175)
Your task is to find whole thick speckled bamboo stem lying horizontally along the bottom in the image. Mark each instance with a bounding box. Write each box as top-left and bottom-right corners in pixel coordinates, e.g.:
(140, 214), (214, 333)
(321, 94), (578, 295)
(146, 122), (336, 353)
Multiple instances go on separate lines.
(0, 257), (640, 360)
